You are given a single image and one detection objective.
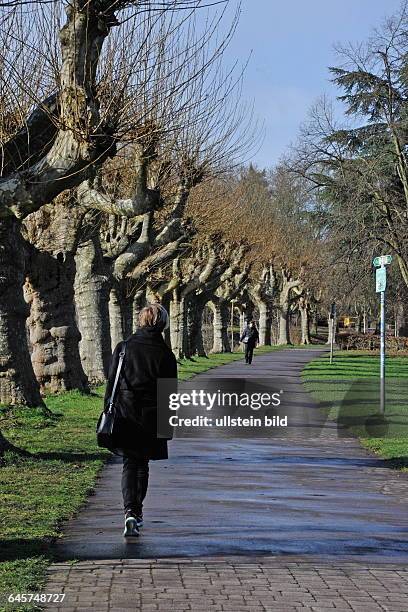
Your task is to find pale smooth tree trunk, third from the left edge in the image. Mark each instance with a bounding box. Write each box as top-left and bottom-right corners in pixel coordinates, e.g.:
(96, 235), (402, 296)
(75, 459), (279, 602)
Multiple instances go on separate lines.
(75, 235), (112, 385)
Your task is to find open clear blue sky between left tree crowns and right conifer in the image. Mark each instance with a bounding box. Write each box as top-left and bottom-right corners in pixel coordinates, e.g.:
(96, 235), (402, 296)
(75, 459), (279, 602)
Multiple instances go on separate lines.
(218, 0), (400, 167)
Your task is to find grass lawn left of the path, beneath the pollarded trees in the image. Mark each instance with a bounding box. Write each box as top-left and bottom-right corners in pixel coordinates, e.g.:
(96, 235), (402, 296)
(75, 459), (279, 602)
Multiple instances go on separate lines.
(0, 347), (284, 611)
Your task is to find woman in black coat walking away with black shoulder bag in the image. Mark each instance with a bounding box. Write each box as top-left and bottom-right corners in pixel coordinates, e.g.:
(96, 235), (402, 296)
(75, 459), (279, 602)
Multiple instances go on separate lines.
(105, 304), (177, 537)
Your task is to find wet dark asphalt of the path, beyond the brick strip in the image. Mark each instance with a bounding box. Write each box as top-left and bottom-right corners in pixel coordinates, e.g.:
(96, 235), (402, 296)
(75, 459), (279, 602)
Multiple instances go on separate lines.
(57, 349), (408, 560)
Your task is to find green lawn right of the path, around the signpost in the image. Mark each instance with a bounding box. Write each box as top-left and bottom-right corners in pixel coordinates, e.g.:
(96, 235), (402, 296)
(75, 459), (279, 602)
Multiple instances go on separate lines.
(302, 351), (408, 470)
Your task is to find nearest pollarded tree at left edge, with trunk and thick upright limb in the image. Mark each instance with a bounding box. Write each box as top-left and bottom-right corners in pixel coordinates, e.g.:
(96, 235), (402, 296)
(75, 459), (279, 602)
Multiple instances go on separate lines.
(0, 2), (120, 405)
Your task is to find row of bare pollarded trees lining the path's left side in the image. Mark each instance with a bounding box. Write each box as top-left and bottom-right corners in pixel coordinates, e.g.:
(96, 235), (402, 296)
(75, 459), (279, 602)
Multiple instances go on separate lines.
(0, 0), (322, 432)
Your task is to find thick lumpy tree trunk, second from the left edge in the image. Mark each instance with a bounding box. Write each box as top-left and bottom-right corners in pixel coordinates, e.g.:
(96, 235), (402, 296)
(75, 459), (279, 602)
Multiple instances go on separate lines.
(25, 249), (89, 393)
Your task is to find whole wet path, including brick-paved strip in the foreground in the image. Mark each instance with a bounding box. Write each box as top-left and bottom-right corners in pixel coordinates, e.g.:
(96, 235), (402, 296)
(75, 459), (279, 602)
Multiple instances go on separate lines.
(43, 349), (408, 612)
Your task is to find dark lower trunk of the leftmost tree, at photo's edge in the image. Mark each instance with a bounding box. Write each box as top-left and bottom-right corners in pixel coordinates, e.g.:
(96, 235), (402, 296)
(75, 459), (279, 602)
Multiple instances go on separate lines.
(0, 217), (43, 406)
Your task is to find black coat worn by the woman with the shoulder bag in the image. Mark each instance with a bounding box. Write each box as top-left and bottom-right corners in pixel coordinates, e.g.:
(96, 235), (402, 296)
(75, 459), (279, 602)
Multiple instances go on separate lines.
(105, 327), (177, 459)
